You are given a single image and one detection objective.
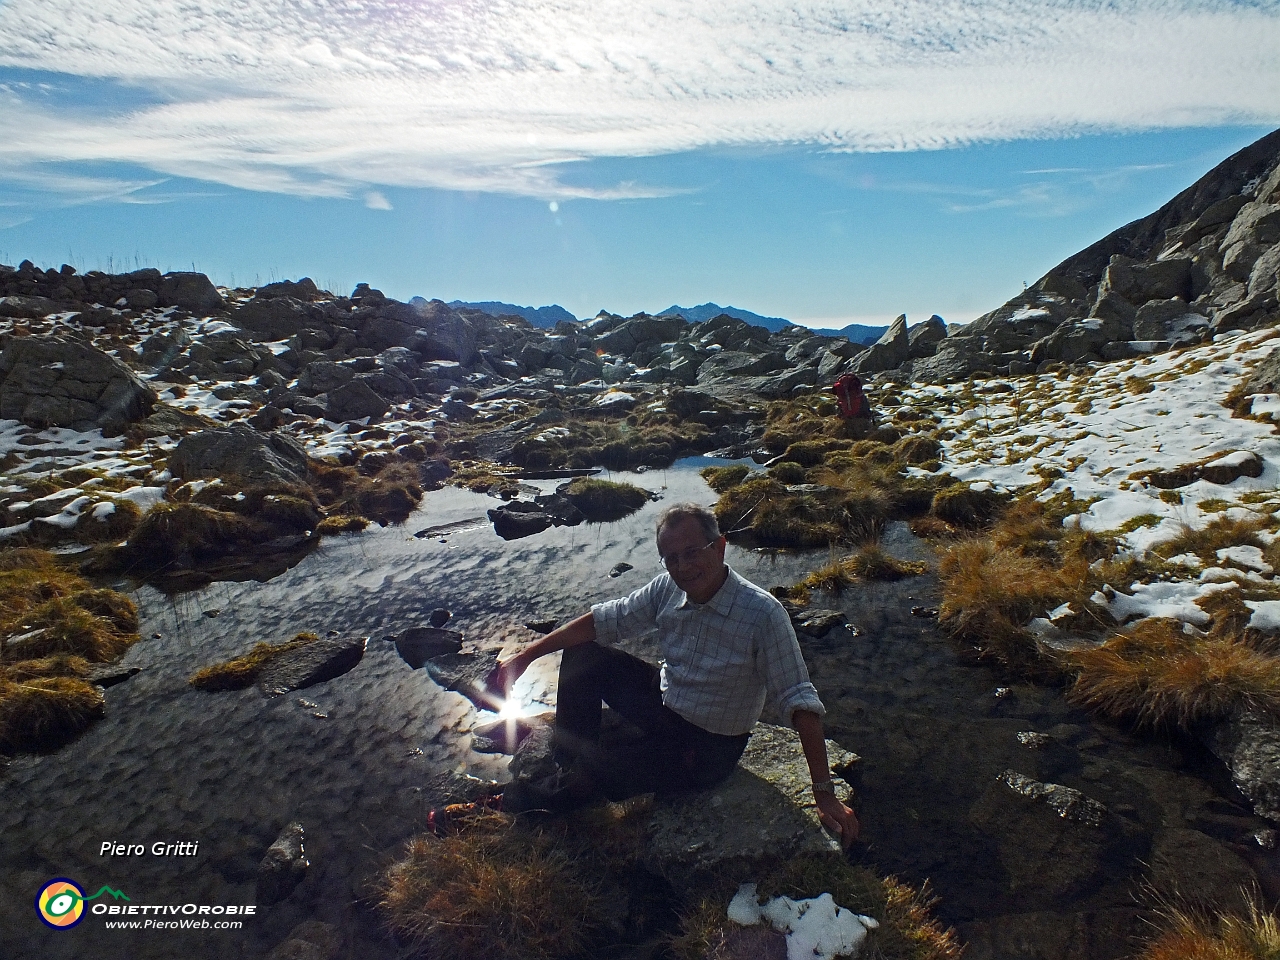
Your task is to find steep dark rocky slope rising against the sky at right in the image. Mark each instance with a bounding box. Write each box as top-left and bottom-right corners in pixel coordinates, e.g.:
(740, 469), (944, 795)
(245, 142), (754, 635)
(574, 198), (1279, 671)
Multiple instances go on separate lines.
(909, 131), (1280, 381)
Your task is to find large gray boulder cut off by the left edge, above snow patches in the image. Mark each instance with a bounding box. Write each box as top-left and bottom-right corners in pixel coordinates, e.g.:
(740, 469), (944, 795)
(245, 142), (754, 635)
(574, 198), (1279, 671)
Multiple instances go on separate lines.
(0, 337), (156, 433)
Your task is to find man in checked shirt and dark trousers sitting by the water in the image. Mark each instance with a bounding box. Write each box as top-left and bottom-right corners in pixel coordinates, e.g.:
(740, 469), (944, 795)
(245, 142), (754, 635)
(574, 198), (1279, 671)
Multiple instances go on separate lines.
(489, 503), (859, 849)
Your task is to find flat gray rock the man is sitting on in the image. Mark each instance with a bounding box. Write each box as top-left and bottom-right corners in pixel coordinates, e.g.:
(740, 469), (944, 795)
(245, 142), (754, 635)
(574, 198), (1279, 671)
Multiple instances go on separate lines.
(646, 723), (859, 878)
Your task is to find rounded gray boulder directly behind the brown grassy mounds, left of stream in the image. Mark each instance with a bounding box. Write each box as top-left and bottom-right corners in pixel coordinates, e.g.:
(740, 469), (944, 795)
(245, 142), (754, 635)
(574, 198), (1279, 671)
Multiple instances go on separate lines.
(169, 424), (307, 484)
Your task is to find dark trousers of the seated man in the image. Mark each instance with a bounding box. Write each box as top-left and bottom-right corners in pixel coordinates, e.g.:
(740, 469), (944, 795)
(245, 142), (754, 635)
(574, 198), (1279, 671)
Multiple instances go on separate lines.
(556, 641), (750, 800)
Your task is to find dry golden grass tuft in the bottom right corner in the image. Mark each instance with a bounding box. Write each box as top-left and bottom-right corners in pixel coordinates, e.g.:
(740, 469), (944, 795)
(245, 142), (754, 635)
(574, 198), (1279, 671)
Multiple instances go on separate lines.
(1137, 896), (1280, 960)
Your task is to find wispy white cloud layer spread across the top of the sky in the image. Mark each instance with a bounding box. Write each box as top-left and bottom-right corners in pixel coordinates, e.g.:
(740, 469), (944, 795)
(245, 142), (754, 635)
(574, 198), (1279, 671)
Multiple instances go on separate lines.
(0, 0), (1280, 200)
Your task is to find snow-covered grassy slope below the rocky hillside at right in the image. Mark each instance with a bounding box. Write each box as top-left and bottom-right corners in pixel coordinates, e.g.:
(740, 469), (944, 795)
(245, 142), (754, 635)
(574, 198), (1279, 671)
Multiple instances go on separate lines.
(886, 328), (1280, 640)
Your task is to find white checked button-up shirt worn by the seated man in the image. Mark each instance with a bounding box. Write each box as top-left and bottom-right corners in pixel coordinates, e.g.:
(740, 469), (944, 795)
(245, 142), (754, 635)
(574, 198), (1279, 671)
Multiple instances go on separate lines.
(591, 570), (827, 736)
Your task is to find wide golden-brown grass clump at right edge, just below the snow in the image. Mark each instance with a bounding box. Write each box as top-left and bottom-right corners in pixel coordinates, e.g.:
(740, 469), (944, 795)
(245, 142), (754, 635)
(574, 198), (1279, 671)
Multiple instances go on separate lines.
(1064, 618), (1280, 727)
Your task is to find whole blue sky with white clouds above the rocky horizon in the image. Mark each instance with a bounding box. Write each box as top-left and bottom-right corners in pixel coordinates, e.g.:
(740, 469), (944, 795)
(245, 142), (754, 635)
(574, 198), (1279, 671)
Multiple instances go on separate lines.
(0, 0), (1280, 326)
